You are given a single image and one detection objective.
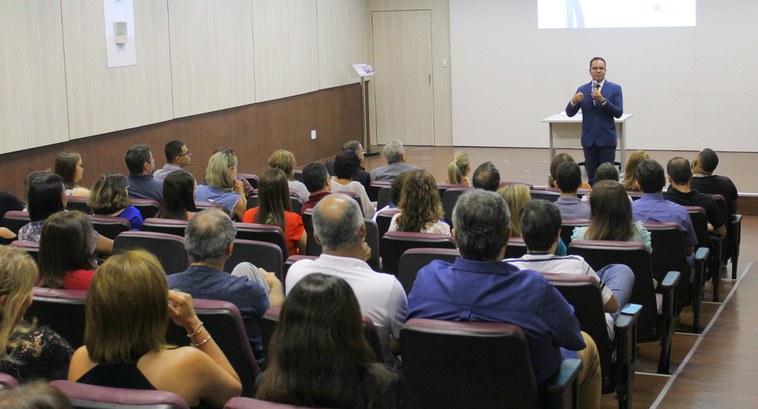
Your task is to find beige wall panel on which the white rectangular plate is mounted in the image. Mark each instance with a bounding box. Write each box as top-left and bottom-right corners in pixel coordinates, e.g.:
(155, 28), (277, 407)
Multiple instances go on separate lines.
(61, 0), (173, 139)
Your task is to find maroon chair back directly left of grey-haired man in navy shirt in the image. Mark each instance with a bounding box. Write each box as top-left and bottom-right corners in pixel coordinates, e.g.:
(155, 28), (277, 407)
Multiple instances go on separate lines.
(113, 231), (189, 274)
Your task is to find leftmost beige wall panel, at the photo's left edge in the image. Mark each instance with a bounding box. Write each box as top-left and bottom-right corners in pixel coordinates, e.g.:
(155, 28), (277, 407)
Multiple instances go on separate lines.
(0, 0), (68, 153)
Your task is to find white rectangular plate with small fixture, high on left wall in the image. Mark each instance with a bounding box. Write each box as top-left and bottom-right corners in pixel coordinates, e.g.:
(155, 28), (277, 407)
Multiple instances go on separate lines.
(103, 0), (137, 68)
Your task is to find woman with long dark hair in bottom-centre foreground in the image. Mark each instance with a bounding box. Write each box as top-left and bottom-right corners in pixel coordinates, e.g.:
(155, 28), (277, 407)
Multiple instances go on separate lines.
(255, 273), (418, 409)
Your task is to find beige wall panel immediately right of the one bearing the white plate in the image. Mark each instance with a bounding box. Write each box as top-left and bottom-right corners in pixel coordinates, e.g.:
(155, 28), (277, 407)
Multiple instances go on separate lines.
(168, 0), (255, 118)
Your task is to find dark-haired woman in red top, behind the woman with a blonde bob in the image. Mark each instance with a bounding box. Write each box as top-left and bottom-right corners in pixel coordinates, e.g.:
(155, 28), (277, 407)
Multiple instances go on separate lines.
(37, 210), (97, 291)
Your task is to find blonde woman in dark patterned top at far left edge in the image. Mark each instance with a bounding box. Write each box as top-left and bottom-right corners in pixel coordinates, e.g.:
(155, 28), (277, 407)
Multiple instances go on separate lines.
(0, 246), (74, 382)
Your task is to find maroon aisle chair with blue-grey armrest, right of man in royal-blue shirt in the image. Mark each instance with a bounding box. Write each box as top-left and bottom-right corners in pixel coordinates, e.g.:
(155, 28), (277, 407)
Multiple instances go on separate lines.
(542, 273), (640, 409)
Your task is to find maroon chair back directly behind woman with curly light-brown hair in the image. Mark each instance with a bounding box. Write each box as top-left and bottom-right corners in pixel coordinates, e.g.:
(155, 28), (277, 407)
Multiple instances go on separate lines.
(381, 231), (456, 275)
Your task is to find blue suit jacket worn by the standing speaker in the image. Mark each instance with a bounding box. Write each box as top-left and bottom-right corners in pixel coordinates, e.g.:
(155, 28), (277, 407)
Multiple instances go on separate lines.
(566, 80), (624, 147)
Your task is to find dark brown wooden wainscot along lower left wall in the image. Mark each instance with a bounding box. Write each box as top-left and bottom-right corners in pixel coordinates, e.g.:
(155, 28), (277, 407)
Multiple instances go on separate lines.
(0, 84), (363, 197)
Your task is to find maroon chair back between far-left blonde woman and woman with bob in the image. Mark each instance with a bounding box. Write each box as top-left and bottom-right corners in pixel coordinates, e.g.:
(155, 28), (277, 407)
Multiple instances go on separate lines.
(25, 287), (87, 348)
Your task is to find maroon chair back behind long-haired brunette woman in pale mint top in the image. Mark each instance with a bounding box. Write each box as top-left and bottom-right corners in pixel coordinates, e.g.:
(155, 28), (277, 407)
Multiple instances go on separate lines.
(568, 240), (660, 342)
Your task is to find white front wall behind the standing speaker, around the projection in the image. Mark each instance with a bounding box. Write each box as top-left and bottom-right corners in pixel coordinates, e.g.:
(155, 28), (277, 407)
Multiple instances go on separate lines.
(450, 0), (758, 151)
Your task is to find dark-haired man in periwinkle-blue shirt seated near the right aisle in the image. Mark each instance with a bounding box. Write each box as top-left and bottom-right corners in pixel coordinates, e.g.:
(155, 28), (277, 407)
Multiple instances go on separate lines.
(632, 159), (697, 255)
